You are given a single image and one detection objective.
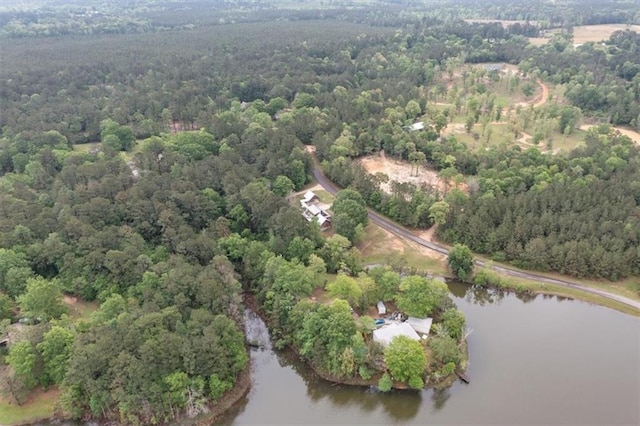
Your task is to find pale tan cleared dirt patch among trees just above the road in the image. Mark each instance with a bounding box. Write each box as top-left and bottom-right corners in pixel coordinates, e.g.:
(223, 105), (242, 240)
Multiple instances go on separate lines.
(360, 154), (447, 193)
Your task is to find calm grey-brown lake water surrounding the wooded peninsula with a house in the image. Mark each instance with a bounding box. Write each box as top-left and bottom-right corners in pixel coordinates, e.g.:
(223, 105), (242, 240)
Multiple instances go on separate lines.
(222, 284), (640, 425)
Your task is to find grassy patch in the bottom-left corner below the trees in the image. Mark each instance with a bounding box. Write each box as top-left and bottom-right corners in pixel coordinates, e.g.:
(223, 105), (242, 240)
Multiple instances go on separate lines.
(0, 389), (60, 426)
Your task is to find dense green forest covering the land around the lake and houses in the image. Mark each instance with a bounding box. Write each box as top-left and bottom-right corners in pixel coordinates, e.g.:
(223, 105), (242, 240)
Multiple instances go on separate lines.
(0, 0), (640, 424)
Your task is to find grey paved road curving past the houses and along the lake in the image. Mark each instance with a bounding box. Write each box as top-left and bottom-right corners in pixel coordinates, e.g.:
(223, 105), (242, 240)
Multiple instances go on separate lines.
(313, 162), (640, 309)
